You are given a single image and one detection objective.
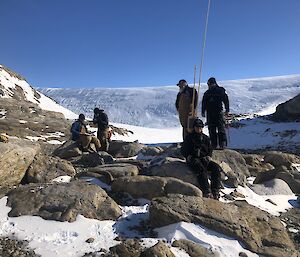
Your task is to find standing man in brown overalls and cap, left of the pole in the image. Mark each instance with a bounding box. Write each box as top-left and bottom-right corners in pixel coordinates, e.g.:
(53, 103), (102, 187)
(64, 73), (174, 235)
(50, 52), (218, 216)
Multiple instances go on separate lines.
(175, 79), (198, 139)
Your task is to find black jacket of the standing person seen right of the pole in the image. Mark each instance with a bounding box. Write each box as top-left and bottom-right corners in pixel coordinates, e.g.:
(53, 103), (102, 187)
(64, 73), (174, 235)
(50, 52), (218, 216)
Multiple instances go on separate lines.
(202, 85), (229, 116)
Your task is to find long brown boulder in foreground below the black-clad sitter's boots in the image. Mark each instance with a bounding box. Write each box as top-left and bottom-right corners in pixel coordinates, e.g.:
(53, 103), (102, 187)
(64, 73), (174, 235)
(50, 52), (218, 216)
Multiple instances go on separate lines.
(149, 195), (297, 257)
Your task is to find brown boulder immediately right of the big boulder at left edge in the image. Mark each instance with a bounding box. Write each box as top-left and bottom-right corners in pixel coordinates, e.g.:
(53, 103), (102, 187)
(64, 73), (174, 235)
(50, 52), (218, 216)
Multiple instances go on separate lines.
(26, 154), (76, 183)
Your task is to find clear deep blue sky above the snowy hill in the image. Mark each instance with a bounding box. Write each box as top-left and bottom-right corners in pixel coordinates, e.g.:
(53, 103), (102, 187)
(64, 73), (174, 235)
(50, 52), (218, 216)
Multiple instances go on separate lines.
(0, 0), (300, 87)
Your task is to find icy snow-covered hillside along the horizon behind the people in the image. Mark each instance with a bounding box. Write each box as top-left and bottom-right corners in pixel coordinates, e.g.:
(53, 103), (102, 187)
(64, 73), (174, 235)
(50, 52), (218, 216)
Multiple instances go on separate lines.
(38, 75), (300, 128)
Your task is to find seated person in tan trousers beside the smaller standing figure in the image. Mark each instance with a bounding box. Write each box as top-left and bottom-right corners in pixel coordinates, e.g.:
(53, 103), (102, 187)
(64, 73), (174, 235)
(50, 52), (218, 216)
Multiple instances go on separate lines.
(71, 113), (101, 152)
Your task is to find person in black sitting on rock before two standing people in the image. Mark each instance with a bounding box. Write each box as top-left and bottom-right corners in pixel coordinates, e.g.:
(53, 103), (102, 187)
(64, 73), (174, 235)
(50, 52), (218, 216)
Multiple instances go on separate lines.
(181, 118), (221, 200)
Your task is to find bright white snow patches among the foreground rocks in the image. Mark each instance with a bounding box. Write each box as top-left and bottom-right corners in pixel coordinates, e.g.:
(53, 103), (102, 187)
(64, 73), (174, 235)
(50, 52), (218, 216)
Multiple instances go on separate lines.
(0, 180), (300, 257)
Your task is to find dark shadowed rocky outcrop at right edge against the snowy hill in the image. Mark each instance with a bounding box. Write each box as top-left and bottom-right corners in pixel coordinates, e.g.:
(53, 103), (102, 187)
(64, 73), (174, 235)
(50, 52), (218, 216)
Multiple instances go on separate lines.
(272, 94), (300, 121)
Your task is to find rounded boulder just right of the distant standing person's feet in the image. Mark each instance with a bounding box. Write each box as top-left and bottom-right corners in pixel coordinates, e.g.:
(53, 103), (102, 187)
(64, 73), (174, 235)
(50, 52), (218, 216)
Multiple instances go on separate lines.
(108, 140), (145, 158)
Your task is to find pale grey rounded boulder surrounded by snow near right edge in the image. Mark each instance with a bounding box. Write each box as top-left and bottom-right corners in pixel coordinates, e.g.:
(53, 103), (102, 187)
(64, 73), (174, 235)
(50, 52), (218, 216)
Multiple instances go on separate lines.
(251, 179), (293, 195)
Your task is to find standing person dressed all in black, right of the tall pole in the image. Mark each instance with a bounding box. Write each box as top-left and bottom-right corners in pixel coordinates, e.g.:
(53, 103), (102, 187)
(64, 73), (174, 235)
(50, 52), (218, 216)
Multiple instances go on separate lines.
(202, 78), (229, 149)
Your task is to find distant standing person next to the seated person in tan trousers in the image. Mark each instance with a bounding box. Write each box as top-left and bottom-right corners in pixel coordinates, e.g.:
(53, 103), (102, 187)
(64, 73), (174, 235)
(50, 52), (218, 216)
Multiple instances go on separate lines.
(93, 108), (109, 152)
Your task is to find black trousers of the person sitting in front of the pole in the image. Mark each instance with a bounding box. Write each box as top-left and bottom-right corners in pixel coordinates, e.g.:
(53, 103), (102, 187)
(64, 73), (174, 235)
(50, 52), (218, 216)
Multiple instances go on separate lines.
(188, 158), (222, 195)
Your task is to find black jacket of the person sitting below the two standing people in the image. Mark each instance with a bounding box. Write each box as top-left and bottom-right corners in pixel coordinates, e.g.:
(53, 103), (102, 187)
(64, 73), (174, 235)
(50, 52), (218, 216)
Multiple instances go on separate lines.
(181, 132), (213, 158)
